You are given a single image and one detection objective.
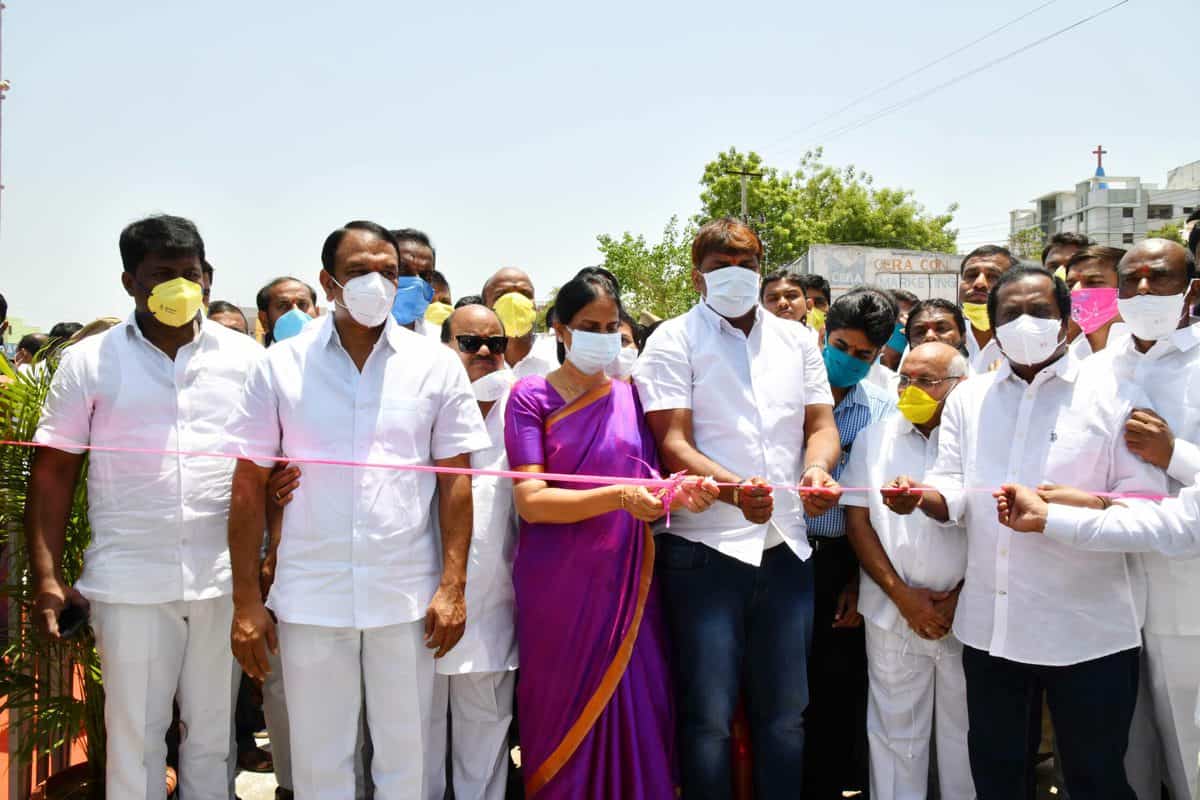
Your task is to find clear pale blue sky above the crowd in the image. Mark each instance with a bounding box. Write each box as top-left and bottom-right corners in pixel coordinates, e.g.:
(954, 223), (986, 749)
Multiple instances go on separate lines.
(0, 0), (1200, 326)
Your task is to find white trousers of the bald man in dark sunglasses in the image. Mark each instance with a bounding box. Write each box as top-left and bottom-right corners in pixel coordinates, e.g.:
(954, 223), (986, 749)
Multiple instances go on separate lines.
(426, 672), (517, 800)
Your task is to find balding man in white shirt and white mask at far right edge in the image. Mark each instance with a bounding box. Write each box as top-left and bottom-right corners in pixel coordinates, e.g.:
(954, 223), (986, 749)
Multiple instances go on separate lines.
(1032, 239), (1200, 800)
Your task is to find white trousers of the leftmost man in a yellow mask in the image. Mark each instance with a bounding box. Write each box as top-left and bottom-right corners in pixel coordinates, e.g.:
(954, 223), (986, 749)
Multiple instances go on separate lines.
(91, 595), (234, 800)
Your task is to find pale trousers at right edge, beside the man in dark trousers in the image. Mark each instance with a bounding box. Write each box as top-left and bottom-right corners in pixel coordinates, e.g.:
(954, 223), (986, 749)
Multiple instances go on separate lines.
(1126, 631), (1200, 800)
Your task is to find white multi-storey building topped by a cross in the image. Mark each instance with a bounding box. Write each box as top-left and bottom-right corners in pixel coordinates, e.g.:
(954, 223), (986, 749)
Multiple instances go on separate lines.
(1008, 154), (1200, 248)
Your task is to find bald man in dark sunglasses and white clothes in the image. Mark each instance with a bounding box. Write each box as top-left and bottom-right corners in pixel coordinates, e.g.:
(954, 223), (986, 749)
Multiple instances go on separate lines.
(428, 306), (517, 800)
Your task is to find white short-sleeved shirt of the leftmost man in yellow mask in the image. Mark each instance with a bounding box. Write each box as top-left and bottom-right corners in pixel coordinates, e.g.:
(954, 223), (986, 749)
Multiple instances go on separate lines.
(34, 315), (263, 603)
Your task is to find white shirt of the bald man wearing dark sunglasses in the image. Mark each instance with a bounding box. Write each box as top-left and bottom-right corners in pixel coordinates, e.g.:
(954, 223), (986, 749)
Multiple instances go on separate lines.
(437, 381), (517, 675)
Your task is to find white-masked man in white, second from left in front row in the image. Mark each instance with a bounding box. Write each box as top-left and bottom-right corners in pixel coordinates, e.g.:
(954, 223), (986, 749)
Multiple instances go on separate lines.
(229, 222), (488, 800)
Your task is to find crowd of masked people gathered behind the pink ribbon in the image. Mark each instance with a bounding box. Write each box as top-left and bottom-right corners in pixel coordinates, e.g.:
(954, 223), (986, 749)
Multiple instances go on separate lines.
(0, 209), (1200, 800)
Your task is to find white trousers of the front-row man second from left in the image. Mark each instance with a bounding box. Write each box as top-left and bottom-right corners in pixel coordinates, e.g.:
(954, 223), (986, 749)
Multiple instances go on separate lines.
(278, 620), (433, 800)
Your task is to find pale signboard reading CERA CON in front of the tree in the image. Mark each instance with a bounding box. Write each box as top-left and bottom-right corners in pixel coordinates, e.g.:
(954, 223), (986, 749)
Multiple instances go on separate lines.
(805, 245), (962, 302)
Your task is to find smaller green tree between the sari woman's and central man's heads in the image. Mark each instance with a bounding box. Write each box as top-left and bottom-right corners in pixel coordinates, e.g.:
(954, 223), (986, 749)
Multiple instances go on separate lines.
(596, 217), (697, 319)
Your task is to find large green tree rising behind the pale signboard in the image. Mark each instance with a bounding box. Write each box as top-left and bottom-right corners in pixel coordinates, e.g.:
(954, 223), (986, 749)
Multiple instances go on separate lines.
(694, 148), (958, 266)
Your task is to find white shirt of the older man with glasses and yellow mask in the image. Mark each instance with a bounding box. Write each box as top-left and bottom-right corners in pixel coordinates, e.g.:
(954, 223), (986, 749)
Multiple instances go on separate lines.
(841, 414), (967, 634)
